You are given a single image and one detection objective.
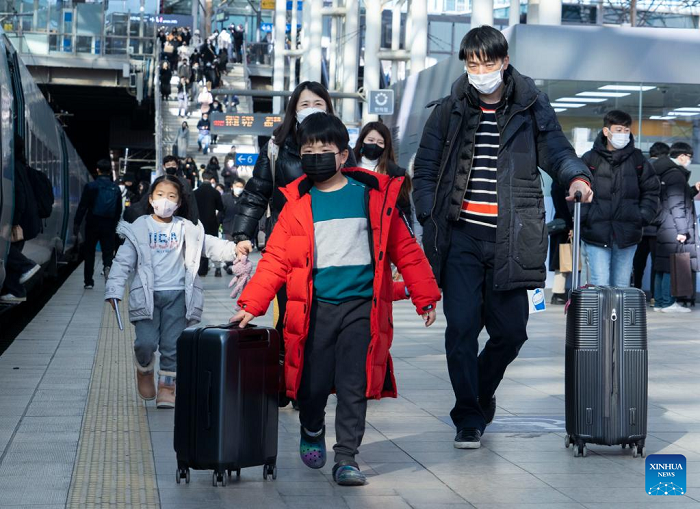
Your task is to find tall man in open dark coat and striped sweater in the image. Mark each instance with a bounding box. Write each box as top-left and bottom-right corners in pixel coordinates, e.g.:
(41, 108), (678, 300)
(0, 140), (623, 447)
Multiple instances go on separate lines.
(413, 26), (591, 449)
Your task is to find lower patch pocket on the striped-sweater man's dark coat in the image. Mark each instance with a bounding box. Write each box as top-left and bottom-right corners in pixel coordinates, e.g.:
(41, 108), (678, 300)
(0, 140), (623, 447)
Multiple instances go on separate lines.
(513, 209), (547, 269)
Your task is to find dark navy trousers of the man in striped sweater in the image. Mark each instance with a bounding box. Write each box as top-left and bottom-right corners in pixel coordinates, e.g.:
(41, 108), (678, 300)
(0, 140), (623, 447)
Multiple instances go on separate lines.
(442, 225), (529, 433)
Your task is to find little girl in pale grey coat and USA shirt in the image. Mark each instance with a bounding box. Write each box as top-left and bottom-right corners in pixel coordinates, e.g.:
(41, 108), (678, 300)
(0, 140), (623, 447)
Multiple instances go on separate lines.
(105, 175), (236, 408)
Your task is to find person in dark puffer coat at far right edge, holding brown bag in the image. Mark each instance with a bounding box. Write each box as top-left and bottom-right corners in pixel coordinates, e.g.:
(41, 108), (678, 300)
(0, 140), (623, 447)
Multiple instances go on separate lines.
(654, 142), (700, 313)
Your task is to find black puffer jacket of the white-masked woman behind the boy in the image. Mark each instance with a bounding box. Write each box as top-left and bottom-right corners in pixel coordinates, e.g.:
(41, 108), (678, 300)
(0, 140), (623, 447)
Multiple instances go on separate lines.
(233, 135), (357, 240)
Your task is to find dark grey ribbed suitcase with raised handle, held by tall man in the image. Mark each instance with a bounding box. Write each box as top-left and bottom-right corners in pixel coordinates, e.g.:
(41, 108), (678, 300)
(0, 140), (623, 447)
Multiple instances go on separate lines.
(565, 192), (648, 457)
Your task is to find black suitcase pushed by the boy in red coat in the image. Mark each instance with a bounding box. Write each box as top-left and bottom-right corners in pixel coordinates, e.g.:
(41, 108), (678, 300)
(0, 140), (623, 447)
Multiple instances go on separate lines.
(174, 324), (280, 486)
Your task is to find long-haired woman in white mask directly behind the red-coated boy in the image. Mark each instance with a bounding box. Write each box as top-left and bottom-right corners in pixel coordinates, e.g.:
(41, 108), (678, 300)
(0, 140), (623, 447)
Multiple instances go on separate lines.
(233, 81), (357, 407)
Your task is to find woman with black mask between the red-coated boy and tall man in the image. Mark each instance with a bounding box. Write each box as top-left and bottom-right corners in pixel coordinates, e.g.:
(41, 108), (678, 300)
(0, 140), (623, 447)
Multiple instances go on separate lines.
(355, 122), (413, 227)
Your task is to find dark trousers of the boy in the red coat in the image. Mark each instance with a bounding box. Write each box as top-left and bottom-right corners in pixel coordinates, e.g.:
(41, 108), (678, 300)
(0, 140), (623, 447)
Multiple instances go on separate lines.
(297, 299), (372, 463)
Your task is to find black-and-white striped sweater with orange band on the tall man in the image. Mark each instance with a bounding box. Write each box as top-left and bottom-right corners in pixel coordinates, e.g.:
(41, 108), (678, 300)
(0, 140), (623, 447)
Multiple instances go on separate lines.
(460, 104), (500, 242)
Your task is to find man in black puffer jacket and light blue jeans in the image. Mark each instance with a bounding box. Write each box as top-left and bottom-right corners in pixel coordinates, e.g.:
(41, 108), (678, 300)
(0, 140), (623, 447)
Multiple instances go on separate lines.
(581, 110), (659, 288)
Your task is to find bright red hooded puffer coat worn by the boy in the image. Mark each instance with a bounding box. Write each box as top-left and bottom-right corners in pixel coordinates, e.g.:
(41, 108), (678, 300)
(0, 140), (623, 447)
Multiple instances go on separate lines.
(238, 168), (440, 399)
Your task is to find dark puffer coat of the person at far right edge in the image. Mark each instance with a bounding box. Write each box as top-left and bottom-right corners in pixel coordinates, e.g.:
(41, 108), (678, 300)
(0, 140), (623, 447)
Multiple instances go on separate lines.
(654, 156), (700, 273)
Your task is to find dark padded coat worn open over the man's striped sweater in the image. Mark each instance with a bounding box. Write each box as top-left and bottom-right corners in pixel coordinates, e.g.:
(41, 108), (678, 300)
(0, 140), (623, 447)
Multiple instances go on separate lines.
(413, 66), (590, 291)
